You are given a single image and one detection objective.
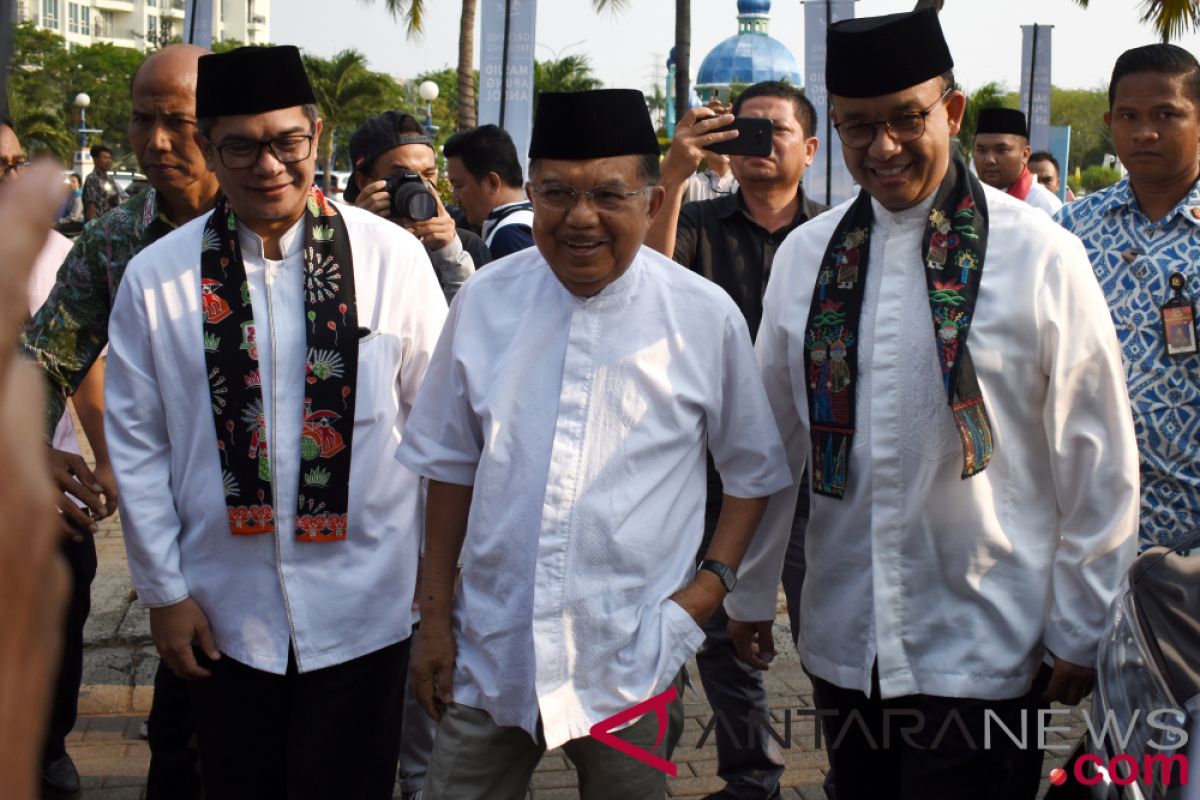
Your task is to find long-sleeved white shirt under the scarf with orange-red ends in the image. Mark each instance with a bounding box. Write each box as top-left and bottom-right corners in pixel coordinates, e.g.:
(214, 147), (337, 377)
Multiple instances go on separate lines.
(104, 203), (446, 674)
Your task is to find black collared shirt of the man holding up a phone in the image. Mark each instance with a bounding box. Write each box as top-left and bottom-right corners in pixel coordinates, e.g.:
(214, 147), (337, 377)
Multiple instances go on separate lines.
(674, 188), (829, 337)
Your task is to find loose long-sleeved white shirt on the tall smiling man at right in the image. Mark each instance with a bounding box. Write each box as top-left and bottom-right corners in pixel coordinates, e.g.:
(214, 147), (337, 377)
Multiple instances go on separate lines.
(725, 188), (1138, 699)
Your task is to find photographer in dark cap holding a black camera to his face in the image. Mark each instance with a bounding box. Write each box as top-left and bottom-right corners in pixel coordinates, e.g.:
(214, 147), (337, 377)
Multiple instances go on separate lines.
(342, 112), (491, 302)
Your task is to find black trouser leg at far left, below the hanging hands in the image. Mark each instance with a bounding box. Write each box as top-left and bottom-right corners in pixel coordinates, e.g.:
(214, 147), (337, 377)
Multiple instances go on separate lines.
(42, 534), (96, 762)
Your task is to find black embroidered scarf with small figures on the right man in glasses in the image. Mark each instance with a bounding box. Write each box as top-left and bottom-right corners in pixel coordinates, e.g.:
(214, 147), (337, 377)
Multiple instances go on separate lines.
(804, 154), (992, 499)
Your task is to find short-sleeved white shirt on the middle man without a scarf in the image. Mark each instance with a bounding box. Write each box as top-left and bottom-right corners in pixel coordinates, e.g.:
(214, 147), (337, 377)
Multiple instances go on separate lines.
(397, 247), (791, 747)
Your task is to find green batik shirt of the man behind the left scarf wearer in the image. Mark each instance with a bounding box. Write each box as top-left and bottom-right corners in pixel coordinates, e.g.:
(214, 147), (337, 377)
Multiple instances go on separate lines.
(20, 188), (175, 435)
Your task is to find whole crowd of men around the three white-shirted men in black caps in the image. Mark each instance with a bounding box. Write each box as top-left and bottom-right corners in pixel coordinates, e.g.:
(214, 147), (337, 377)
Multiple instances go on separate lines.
(0, 11), (1200, 800)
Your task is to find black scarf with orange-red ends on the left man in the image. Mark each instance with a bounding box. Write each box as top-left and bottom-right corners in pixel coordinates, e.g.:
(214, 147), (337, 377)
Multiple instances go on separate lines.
(200, 188), (359, 542)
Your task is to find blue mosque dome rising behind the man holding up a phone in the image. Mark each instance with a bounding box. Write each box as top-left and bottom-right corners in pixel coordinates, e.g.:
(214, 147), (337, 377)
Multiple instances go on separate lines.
(696, 0), (803, 98)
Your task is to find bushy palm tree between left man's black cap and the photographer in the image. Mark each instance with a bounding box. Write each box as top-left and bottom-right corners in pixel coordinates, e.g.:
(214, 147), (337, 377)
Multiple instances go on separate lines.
(305, 49), (396, 192)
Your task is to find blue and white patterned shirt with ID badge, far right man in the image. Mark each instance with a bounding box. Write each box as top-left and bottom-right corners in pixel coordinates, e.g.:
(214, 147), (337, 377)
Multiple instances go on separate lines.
(1055, 179), (1200, 548)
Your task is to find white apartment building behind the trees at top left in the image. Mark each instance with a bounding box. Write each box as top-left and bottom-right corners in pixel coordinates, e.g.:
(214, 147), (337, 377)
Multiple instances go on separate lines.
(16, 0), (270, 50)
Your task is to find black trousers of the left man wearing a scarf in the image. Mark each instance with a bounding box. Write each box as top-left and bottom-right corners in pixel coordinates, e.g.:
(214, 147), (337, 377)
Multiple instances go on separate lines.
(188, 639), (409, 800)
